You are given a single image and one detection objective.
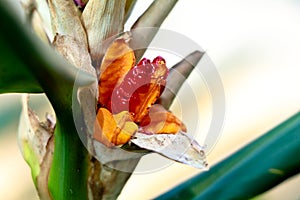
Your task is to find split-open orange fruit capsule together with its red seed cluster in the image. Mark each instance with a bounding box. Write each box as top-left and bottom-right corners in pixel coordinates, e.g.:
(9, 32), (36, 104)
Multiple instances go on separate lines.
(94, 39), (186, 146)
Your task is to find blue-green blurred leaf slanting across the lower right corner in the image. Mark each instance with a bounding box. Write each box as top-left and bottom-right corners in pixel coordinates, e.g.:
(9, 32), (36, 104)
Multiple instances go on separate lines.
(156, 112), (300, 200)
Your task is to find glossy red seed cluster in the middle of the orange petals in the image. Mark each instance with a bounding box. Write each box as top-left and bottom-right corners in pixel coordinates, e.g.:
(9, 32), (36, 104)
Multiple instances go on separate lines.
(110, 56), (168, 120)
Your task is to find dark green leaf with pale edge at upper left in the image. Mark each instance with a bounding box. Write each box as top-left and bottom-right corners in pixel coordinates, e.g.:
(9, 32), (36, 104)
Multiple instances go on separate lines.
(0, 1), (95, 96)
